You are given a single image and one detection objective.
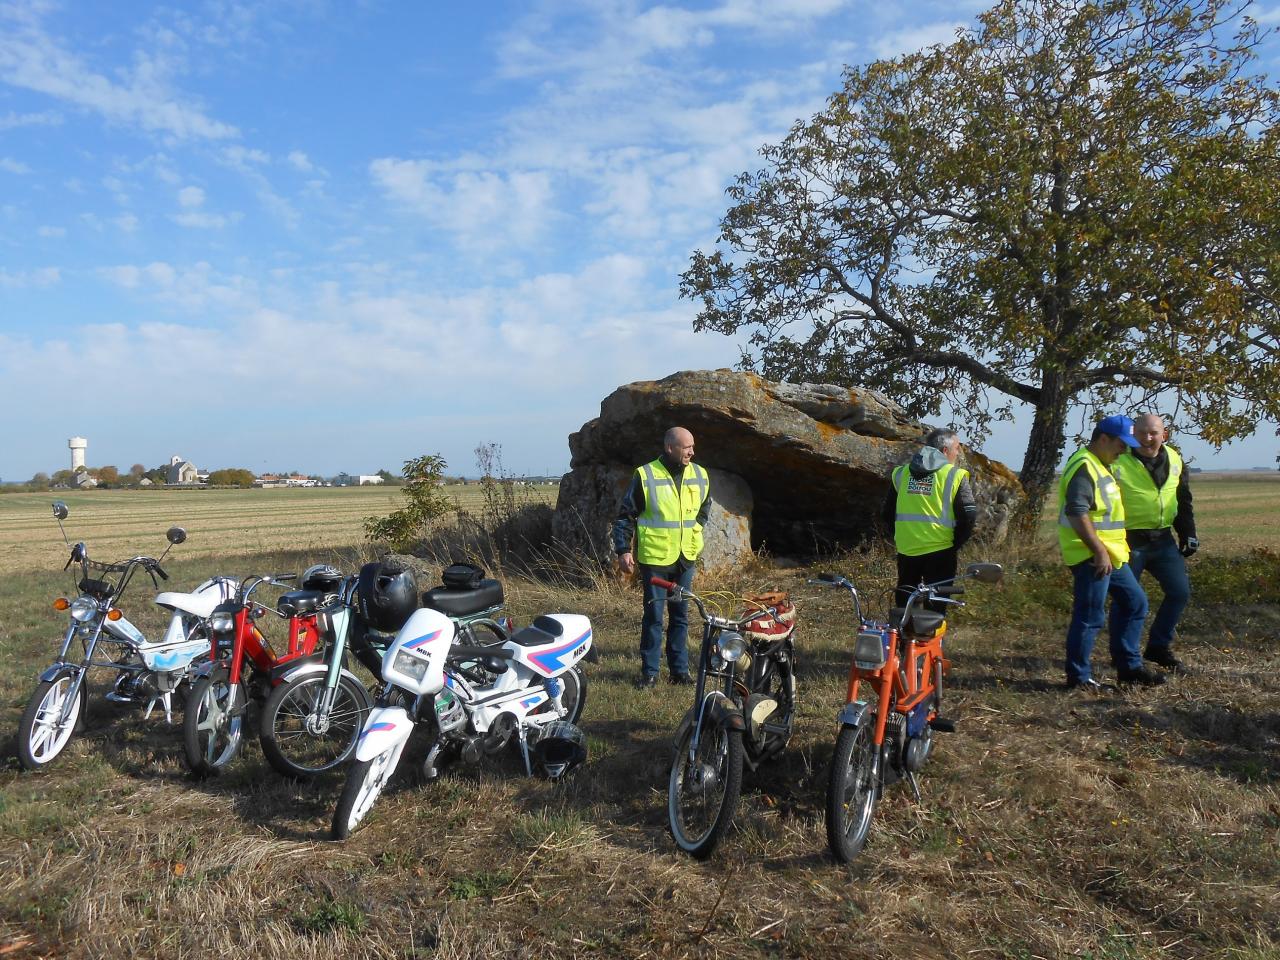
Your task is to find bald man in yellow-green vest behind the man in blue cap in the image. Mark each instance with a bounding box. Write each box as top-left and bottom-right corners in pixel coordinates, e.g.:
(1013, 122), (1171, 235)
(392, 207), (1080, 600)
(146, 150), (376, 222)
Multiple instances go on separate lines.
(1111, 413), (1199, 673)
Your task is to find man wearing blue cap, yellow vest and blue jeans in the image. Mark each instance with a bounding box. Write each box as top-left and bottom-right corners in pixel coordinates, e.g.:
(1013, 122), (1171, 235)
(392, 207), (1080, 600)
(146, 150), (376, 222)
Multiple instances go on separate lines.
(1057, 415), (1165, 690)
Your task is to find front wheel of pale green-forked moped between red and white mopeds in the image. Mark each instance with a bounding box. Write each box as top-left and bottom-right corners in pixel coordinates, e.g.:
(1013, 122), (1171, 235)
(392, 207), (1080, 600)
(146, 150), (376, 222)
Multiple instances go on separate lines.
(259, 672), (372, 778)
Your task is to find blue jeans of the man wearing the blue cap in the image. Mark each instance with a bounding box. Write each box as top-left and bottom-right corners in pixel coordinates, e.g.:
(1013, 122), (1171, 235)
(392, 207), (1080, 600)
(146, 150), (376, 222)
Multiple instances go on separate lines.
(1066, 559), (1147, 684)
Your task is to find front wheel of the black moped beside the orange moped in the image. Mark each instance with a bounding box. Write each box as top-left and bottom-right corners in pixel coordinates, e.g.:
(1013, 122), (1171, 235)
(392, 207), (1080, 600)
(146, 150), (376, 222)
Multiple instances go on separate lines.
(667, 721), (742, 860)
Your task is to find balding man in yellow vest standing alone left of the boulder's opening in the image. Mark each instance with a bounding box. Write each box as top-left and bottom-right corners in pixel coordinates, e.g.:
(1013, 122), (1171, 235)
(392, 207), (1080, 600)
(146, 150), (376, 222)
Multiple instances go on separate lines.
(613, 426), (710, 689)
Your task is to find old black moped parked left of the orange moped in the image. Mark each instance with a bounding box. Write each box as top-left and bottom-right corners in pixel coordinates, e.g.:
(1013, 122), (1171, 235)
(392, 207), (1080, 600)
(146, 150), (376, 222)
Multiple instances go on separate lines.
(649, 577), (796, 860)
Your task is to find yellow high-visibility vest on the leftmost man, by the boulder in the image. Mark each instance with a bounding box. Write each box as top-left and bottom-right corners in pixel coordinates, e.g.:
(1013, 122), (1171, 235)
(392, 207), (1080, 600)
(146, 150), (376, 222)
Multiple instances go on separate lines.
(636, 460), (712, 567)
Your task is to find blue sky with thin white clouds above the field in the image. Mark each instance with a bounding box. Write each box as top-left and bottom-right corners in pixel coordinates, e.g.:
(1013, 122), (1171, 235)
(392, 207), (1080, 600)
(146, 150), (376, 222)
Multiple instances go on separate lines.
(0, 0), (1280, 480)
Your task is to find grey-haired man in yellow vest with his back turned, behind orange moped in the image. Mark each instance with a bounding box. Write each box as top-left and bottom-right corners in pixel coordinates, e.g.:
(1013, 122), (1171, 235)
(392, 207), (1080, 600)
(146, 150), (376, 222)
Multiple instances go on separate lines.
(881, 430), (978, 608)
